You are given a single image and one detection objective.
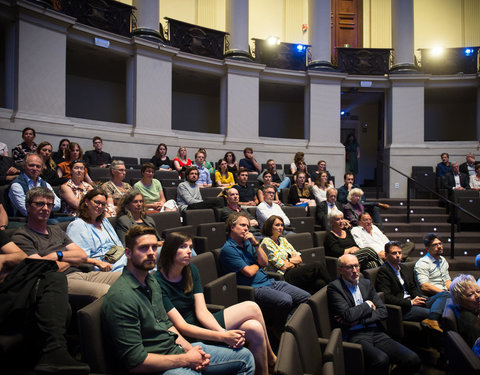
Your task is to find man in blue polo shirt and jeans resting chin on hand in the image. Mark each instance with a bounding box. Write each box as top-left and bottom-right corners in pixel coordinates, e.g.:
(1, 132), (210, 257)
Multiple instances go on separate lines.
(220, 214), (310, 328)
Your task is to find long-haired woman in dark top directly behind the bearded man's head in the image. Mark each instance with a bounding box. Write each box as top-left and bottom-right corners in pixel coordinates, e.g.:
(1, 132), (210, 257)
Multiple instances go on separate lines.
(115, 189), (163, 246)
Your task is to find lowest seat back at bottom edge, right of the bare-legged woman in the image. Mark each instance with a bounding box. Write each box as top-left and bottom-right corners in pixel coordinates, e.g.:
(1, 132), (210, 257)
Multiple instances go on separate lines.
(273, 332), (303, 375)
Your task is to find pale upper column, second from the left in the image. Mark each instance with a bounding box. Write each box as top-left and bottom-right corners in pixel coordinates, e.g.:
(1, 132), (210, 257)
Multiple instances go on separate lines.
(225, 0), (252, 61)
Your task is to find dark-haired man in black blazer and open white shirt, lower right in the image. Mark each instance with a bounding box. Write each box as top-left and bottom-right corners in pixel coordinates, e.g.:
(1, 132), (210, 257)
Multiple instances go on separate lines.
(375, 241), (442, 332)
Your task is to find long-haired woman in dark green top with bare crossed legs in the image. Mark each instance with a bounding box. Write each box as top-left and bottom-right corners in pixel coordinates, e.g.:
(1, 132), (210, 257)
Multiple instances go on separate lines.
(155, 232), (277, 375)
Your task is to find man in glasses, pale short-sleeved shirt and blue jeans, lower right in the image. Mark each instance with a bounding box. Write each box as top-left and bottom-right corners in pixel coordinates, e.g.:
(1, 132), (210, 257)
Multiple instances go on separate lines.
(415, 233), (452, 328)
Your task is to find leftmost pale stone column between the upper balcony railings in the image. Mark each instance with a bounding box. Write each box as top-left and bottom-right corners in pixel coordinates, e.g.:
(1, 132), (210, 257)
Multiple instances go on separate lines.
(132, 0), (165, 42)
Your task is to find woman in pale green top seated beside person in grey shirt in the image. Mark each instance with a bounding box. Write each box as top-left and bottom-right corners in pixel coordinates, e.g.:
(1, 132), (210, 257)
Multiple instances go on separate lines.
(133, 163), (177, 212)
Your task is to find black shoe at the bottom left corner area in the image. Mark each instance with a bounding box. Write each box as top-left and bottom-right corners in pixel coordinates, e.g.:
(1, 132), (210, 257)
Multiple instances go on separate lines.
(34, 348), (90, 375)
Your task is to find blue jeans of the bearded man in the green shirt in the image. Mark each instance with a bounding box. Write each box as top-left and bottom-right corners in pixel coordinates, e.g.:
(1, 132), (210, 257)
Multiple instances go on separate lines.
(158, 342), (255, 375)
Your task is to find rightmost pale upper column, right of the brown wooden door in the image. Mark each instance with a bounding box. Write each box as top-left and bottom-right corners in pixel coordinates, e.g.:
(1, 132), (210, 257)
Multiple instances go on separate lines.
(392, 0), (417, 72)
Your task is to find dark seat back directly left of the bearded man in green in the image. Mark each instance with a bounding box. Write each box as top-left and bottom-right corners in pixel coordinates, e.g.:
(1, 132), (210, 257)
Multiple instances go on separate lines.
(77, 297), (110, 374)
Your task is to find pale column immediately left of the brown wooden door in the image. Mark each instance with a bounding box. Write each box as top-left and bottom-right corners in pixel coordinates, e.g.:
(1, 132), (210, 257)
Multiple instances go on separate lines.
(308, 0), (333, 70)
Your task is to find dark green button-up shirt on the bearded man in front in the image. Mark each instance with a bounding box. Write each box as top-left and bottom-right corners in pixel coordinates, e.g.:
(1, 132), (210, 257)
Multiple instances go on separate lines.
(102, 268), (184, 370)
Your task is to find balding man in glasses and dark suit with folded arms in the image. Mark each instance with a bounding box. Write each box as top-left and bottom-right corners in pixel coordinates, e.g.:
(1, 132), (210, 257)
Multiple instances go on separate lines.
(327, 254), (421, 375)
